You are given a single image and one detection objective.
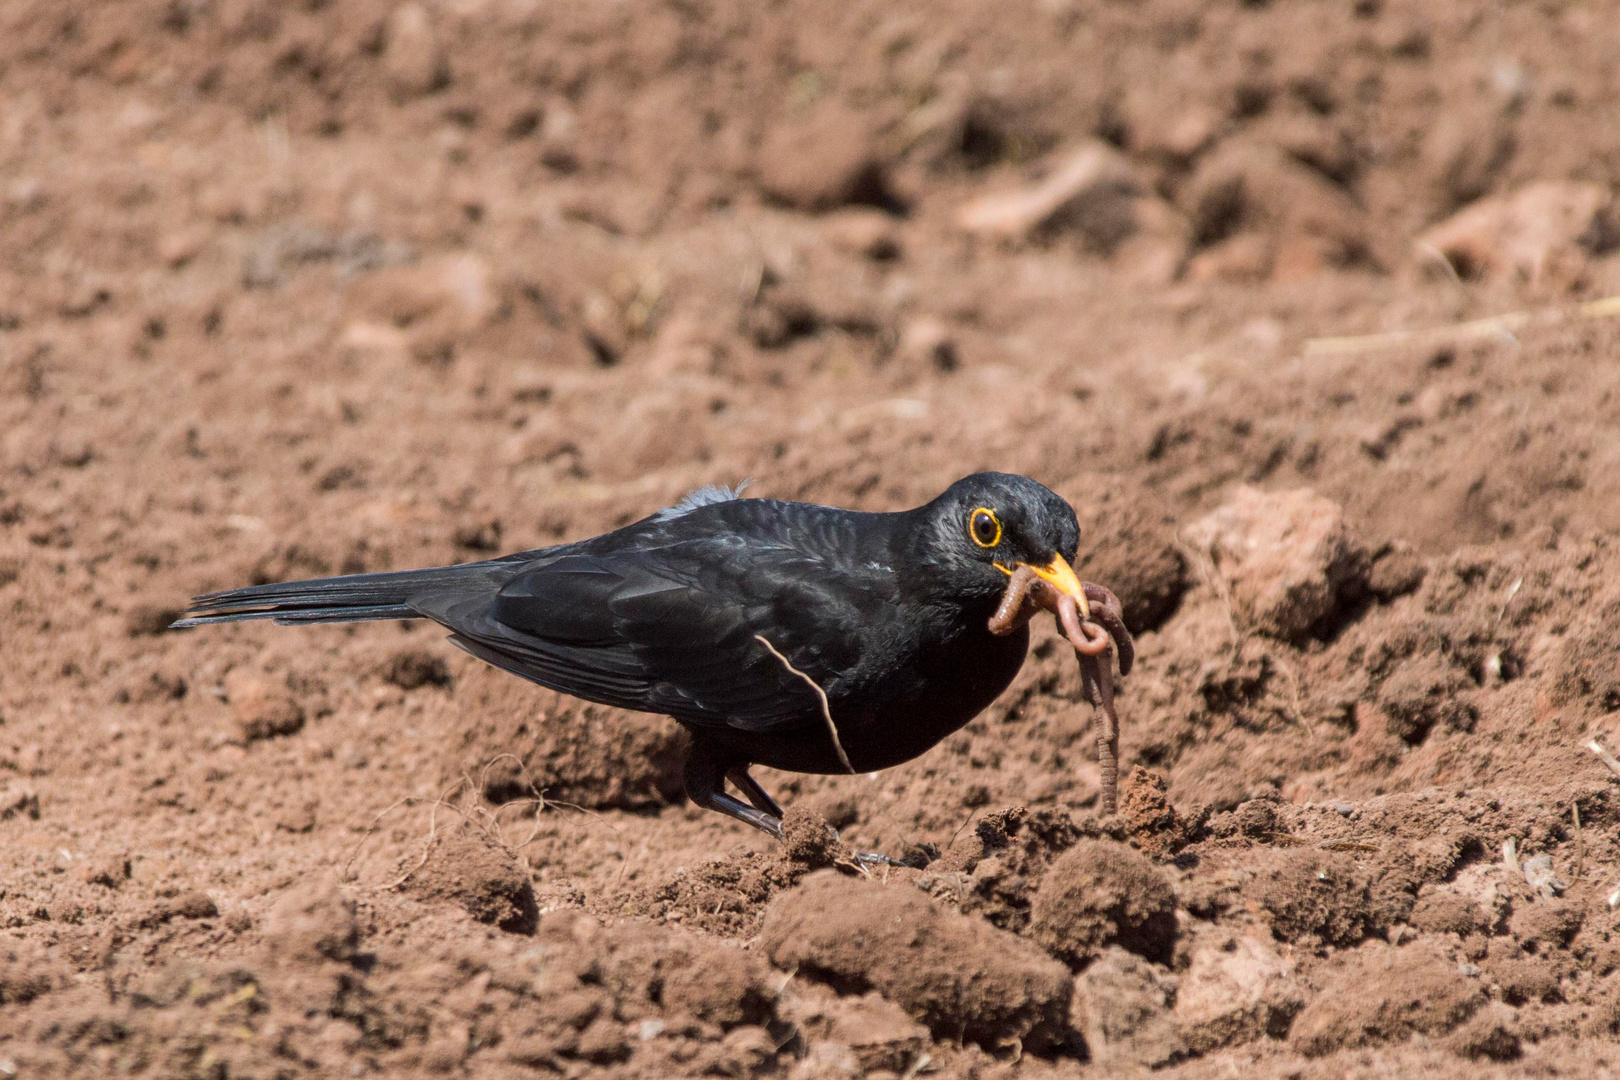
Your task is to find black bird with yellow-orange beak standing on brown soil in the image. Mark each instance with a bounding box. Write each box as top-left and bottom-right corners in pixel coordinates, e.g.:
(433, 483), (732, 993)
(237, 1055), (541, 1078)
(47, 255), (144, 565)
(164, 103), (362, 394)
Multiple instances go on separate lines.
(175, 473), (1129, 837)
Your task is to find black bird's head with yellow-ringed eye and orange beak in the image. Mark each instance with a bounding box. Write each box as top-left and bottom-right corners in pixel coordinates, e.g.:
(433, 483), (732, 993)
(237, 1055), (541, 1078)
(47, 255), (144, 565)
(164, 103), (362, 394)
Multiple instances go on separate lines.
(915, 473), (1081, 599)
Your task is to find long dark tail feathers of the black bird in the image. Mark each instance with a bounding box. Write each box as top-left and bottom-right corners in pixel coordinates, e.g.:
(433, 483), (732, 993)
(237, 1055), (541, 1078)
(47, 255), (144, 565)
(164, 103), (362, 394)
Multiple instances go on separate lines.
(173, 563), (491, 628)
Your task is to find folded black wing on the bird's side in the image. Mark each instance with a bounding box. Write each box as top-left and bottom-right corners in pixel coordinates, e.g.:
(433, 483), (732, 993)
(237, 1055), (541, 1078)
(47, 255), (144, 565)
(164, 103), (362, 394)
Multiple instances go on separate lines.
(413, 534), (880, 730)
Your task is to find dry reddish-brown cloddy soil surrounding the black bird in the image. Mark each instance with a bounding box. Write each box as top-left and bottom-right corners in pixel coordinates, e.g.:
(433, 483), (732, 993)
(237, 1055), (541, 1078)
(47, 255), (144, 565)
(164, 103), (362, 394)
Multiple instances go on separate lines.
(0, 0), (1620, 1080)
